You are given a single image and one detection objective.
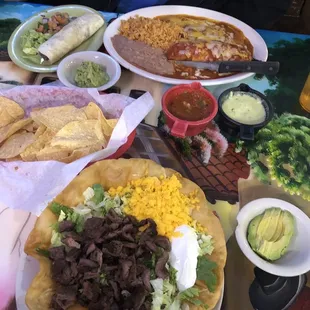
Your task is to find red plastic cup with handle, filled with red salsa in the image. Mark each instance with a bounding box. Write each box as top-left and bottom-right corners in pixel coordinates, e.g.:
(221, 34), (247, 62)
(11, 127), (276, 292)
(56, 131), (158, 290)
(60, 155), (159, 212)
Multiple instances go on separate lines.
(162, 82), (218, 138)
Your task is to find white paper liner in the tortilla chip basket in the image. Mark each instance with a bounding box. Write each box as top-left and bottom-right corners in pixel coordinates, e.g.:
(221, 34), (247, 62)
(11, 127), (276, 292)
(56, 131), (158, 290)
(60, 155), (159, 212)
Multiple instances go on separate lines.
(0, 86), (154, 215)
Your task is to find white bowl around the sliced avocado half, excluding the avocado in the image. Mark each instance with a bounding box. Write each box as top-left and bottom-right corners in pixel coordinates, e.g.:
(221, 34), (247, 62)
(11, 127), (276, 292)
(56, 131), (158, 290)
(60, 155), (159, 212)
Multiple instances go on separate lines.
(236, 198), (310, 277)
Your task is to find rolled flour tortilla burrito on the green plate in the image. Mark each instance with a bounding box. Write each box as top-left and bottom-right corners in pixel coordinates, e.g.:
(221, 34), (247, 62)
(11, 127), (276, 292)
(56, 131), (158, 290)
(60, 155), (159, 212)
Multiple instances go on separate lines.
(39, 13), (104, 64)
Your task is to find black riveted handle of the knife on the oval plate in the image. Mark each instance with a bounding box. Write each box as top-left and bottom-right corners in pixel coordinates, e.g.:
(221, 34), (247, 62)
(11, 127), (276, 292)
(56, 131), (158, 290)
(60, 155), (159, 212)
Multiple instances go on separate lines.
(218, 61), (280, 75)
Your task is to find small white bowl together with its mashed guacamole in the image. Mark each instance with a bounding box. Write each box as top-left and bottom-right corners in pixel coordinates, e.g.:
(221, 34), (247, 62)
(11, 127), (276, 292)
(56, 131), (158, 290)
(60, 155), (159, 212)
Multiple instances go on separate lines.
(57, 51), (121, 91)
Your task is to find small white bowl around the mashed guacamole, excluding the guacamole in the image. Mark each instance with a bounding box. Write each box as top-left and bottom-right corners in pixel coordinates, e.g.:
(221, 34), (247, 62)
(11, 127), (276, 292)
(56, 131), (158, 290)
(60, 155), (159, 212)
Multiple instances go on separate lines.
(57, 51), (121, 91)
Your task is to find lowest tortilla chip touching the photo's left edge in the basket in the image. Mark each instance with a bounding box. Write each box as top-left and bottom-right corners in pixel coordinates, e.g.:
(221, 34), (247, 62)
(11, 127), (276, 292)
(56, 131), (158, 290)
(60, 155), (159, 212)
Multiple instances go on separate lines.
(0, 132), (35, 159)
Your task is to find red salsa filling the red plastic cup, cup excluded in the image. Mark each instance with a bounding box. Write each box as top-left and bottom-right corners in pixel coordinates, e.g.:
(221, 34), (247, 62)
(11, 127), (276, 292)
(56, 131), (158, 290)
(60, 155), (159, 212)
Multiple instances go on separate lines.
(167, 91), (212, 122)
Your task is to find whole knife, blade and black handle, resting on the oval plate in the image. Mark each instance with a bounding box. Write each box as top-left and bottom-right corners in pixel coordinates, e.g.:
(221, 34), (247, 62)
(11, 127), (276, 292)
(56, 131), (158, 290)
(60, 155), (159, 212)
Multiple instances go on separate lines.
(175, 61), (280, 75)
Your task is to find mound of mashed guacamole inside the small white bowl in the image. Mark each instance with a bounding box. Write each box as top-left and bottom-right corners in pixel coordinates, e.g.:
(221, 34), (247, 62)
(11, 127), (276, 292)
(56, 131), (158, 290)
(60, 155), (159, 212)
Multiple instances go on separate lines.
(74, 61), (110, 88)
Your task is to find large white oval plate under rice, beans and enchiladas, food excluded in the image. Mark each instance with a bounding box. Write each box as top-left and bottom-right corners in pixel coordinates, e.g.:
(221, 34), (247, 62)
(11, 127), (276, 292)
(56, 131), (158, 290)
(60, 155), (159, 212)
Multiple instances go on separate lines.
(103, 5), (268, 86)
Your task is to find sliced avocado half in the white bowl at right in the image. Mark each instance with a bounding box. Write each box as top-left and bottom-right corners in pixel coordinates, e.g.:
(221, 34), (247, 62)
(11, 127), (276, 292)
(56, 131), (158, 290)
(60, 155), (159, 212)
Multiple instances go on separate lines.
(248, 208), (295, 261)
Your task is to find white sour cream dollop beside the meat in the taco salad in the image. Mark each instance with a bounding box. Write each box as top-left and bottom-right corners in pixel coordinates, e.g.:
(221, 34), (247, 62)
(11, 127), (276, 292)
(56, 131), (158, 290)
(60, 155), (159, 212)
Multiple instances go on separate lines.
(169, 225), (199, 292)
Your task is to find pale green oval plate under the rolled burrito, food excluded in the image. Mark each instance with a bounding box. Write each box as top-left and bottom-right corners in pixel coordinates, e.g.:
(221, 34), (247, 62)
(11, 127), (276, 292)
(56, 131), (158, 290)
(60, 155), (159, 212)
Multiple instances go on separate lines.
(8, 5), (106, 73)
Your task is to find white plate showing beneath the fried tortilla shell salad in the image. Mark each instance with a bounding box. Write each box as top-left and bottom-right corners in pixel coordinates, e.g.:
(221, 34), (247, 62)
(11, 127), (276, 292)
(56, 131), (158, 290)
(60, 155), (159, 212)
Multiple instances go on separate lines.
(15, 252), (224, 310)
